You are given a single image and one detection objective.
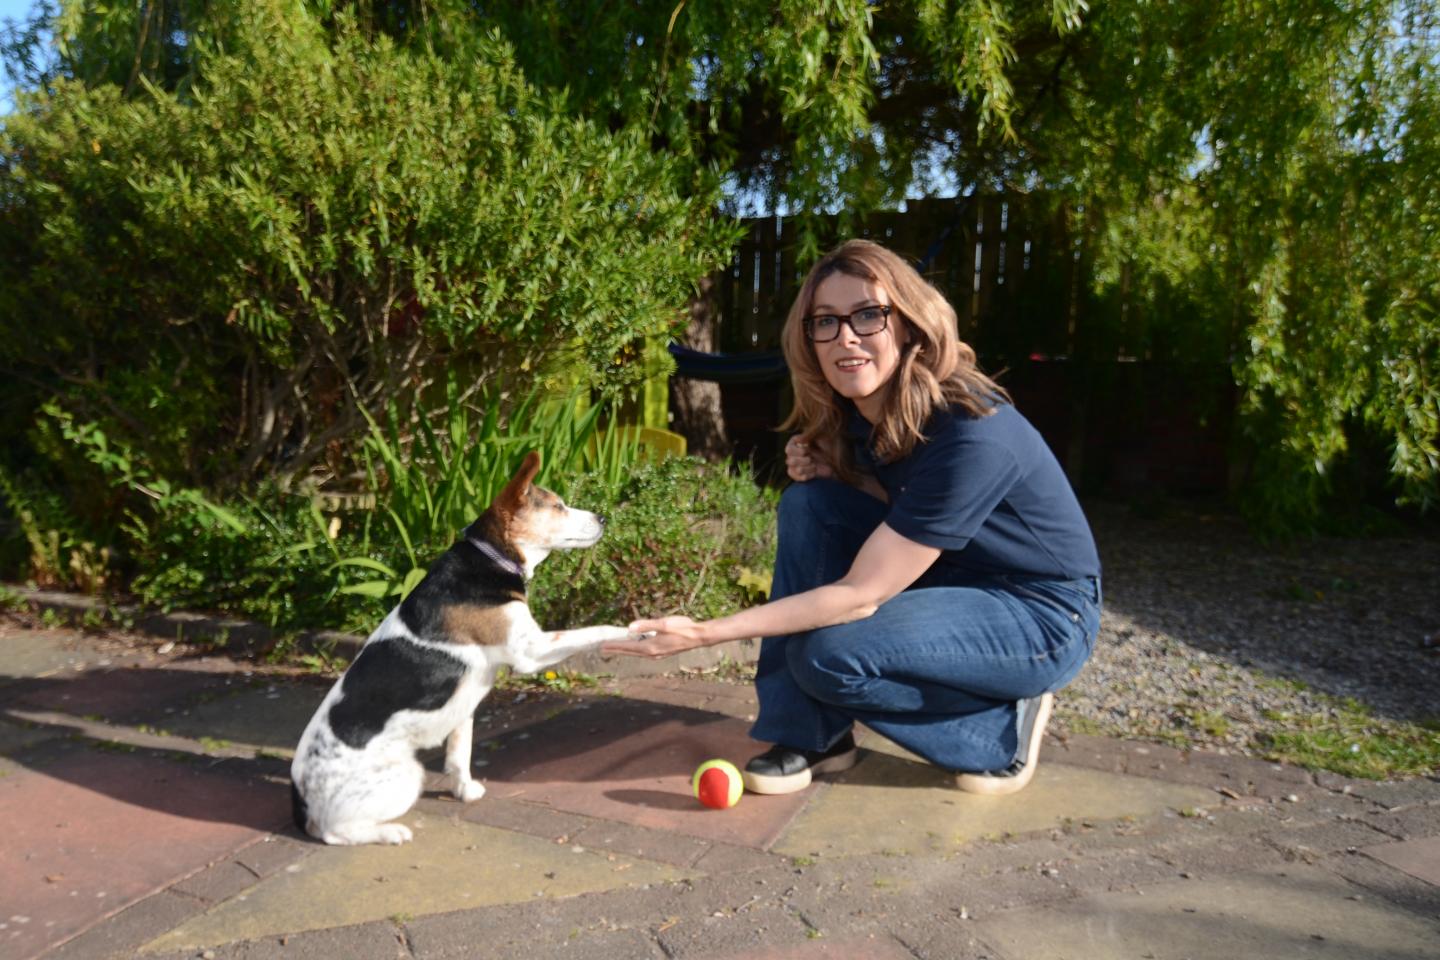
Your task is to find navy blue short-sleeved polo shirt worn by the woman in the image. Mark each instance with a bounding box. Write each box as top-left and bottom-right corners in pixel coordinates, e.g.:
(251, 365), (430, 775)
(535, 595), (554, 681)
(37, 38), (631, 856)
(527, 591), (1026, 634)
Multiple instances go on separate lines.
(850, 403), (1100, 580)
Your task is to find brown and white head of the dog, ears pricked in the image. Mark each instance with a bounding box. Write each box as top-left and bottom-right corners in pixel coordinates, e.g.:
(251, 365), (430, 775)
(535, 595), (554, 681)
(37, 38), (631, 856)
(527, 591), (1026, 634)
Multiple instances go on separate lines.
(474, 450), (605, 579)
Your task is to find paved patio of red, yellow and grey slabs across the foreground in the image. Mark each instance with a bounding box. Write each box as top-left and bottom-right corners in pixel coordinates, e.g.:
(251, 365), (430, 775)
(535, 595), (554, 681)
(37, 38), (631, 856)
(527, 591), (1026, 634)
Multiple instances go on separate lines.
(11, 623), (1440, 960)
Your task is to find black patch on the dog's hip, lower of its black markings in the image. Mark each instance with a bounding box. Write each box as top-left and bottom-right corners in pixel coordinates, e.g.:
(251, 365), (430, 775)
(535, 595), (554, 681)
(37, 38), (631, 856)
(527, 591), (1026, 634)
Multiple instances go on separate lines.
(330, 638), (465, 750)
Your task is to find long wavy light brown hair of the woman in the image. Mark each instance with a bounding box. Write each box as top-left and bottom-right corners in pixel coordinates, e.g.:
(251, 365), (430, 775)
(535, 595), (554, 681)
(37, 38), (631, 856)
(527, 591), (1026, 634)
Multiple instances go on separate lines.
(780, 240), (1011, 482)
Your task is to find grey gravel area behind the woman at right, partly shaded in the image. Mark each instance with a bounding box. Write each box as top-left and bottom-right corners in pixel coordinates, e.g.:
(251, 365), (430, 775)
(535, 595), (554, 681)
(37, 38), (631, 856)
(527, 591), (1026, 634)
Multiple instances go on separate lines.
(1056, 502), (1440, 754)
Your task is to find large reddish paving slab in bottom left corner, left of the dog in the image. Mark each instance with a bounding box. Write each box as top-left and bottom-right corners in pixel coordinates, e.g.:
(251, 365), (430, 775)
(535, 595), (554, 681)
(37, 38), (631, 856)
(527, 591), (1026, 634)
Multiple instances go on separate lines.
(0, 743), (288, 957)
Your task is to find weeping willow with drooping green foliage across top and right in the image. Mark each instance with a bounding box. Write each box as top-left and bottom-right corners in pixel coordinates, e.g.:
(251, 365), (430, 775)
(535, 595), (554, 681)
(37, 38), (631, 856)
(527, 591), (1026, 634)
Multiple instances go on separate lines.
(5, 0), (1440, 524)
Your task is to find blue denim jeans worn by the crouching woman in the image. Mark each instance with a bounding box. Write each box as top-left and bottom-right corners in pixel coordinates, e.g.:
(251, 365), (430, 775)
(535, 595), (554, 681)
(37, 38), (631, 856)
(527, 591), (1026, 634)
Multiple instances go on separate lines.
(750, 479), (1100, 771)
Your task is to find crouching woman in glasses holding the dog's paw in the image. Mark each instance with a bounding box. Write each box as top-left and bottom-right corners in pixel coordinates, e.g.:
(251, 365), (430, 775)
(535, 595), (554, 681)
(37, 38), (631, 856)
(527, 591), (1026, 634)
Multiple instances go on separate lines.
(605, 240), (1100, 793)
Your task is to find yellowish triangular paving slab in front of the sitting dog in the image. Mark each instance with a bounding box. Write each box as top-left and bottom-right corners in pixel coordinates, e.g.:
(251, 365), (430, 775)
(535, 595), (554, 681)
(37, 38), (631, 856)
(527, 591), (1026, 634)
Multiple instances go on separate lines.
(144, 800), (685, 953)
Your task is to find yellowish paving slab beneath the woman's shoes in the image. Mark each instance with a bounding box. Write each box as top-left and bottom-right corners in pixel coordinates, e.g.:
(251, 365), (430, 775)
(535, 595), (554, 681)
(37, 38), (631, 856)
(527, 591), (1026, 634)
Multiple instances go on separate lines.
(773, 737), (1215, 856)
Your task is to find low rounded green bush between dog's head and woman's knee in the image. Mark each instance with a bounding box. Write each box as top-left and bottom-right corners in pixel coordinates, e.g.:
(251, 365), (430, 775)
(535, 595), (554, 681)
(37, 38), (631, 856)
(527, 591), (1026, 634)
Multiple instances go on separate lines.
(530, 458), (776, 628)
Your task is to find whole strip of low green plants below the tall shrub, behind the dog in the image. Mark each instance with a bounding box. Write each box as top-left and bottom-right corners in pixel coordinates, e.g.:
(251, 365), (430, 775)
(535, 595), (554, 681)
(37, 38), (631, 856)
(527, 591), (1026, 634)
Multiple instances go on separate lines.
(0, 374), (776, 644)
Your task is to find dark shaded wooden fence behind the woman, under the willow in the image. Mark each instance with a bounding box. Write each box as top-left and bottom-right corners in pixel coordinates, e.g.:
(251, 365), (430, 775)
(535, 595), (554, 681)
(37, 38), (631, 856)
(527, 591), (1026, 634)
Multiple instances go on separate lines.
(691, 196), (1233, 494)
